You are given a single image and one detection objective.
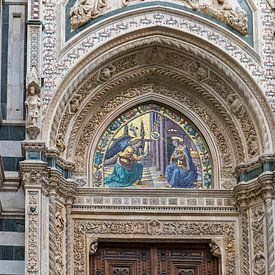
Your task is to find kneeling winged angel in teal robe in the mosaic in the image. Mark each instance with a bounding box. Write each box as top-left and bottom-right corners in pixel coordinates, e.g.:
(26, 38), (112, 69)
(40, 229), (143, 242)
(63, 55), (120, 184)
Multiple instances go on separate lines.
(104, 137), (143, 187)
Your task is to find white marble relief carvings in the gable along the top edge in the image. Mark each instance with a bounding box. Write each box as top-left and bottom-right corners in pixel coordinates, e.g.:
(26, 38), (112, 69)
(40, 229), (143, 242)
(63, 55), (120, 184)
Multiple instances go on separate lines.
(70, 0), (248, 35)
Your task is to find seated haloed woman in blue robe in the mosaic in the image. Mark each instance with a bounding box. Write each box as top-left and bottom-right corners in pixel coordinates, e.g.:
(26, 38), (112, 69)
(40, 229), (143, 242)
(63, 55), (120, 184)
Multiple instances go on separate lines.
(165, 137), (198, 188)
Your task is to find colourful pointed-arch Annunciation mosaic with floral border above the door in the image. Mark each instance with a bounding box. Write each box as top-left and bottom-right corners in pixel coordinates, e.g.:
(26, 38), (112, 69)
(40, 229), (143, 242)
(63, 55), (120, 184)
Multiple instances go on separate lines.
(92, 103), (212, 189)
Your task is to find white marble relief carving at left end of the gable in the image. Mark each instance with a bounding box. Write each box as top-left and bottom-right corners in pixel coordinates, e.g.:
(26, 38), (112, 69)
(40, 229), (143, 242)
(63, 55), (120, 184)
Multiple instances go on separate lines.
(70, 0), (107, 29)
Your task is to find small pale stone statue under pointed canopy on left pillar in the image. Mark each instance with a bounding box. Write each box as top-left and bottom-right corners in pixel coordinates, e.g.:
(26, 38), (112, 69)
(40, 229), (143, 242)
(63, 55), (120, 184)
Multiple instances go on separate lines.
(25, 66), (42, 139)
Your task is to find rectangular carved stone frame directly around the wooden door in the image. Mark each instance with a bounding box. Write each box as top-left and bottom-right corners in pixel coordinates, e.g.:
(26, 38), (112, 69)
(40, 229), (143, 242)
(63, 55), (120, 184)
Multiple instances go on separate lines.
(73, 219), (238, 275)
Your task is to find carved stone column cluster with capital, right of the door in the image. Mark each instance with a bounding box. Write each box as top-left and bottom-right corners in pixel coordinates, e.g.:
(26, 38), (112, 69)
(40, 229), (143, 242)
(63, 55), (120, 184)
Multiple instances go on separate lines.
(234, 172), (274, 275)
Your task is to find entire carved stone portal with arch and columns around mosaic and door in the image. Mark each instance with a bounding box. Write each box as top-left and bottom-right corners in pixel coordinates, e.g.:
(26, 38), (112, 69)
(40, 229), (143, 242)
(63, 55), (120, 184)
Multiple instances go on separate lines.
(21, 21), (275, 274)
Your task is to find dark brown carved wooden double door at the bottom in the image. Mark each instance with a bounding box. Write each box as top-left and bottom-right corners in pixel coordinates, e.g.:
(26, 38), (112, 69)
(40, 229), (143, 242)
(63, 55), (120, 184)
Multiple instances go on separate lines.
(90, 242), (219, 275)
